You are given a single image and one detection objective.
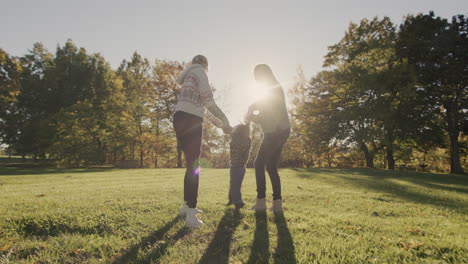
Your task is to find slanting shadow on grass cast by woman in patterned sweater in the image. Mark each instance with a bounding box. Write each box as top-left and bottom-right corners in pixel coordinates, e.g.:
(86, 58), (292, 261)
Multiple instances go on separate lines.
(112, 217), (187, 264)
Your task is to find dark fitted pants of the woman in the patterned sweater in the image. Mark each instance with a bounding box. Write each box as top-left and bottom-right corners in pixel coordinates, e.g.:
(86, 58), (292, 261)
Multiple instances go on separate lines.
(174, 111), (203, 208)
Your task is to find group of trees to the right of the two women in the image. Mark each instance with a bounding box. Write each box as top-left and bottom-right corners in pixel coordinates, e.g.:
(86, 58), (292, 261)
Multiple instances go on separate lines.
(284, 12), (468, 173)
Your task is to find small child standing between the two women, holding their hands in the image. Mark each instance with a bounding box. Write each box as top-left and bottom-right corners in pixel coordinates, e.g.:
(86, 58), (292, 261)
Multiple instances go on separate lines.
(228, 124), (252, 208)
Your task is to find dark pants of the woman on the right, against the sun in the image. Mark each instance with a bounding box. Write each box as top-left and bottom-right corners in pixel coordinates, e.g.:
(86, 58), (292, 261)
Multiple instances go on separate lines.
(254, 129), (291, 200)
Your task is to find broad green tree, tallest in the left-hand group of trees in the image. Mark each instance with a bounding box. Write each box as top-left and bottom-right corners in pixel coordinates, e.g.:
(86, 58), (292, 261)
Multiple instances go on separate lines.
(50, 41), (126, 167)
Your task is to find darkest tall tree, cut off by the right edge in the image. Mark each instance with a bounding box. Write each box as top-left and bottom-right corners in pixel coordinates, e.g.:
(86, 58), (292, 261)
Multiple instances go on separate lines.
(398, 12), (468, 173)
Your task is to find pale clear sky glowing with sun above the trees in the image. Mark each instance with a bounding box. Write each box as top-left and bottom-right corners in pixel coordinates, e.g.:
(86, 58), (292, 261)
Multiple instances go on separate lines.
(0, 0), (468, 124)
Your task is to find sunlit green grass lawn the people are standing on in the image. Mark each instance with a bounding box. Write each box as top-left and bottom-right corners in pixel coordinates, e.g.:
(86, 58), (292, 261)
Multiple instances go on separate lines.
(0, 167), (468, 263)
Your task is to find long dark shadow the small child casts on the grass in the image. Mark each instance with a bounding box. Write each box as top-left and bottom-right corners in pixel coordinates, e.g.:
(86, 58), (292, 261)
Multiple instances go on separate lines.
(198, 208), (242, 264)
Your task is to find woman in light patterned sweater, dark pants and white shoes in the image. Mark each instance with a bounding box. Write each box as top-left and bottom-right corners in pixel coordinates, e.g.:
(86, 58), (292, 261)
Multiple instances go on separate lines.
(173, 55), (231, 228)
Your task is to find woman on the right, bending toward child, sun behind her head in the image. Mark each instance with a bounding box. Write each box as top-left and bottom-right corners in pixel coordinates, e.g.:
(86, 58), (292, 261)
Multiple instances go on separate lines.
(245, 64), (291, 212)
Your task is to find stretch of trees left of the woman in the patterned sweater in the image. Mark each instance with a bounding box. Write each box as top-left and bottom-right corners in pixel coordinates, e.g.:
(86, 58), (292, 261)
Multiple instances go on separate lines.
(0, 40), (186, 167)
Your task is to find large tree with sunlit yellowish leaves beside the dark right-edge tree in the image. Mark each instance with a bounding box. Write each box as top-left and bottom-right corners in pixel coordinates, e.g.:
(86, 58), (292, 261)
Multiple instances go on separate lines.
(324, 17), (423, 169)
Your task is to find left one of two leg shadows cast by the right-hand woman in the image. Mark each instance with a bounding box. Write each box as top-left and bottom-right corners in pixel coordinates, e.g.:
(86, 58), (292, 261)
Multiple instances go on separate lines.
(247, 211), (270, 264)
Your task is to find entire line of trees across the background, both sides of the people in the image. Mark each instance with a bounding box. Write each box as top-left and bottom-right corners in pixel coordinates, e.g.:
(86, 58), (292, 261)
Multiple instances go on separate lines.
(0, 12), (468, 173)
